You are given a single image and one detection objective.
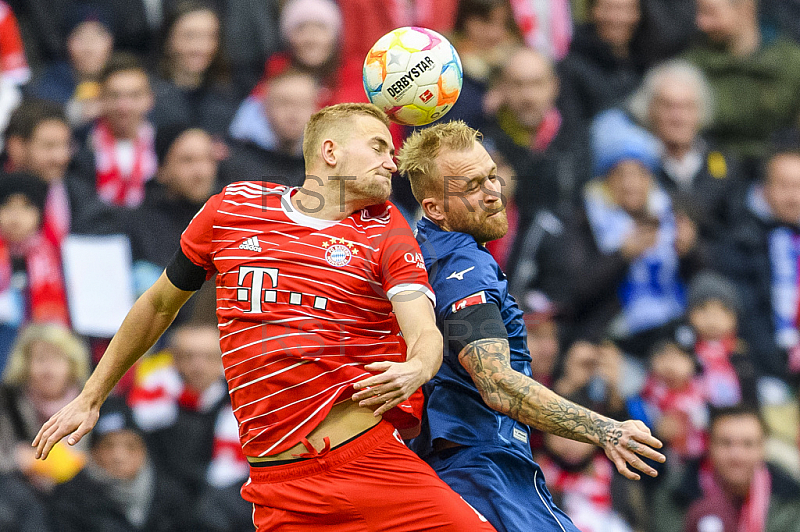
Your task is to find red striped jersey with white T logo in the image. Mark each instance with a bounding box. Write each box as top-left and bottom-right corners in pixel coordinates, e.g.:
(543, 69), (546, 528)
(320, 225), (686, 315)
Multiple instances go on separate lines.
(181, 182), (434, 456)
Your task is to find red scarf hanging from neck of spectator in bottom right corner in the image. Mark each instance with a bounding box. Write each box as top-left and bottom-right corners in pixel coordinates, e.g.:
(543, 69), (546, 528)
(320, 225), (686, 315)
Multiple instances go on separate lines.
(700, 462), (772, 532)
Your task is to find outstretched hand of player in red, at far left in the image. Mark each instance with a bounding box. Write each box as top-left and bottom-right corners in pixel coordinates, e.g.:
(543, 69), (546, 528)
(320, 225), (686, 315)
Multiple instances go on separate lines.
(32, 394), (100, 460)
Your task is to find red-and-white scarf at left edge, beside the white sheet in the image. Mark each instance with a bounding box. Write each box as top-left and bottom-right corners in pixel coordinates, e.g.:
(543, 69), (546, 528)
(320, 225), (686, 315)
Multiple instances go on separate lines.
(0, 233), (69, 326)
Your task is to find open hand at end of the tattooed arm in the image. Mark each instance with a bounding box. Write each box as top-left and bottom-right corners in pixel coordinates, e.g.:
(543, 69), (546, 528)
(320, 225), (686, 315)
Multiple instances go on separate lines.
(600, 420), (666, 480)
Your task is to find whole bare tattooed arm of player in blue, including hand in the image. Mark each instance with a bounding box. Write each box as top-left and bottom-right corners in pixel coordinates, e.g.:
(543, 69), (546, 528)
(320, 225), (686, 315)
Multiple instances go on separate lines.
(458, 338), (664, 480)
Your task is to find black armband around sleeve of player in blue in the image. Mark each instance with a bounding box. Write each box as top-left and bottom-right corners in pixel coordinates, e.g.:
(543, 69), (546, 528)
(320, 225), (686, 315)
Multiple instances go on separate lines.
(443, 303), (508, 353)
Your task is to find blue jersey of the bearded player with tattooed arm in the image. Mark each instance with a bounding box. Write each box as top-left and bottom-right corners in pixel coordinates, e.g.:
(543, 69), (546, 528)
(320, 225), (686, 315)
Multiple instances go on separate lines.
(412, 218), (531, 457)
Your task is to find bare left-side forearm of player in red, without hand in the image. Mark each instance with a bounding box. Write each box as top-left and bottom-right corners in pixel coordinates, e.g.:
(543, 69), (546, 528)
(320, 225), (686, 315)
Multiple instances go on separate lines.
(82, 276), (191, 406)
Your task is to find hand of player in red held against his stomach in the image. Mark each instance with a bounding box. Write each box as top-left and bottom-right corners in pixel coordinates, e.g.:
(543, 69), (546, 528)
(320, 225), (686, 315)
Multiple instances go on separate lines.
(353, 358), (429, 416)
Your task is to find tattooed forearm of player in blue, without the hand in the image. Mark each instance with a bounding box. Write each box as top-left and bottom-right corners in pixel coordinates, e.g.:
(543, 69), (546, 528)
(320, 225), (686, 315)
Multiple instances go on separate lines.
(458, 338), (622, 445)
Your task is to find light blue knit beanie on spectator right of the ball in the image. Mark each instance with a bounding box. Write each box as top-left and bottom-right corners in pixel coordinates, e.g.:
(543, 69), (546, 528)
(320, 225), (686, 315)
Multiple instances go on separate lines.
(591, 109), (660, 177)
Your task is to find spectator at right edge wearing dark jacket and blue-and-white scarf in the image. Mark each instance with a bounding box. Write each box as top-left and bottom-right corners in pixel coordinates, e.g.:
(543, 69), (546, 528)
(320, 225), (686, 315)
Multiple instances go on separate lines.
(715, 148), (800, 382)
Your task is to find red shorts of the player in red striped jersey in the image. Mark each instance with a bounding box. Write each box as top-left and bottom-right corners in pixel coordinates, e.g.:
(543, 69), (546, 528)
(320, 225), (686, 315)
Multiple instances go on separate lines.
(242, 421), (494, 532)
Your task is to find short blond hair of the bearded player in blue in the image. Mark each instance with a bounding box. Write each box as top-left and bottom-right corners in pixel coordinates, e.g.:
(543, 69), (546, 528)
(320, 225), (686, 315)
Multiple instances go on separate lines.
(397, 120), (483, 204)
